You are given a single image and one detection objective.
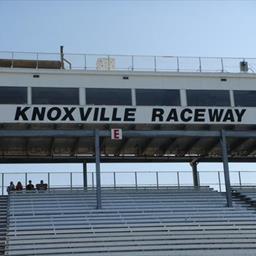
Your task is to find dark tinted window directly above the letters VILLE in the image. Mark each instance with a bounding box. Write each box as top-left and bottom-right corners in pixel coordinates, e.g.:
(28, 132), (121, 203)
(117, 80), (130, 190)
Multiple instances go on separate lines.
(86, 88), (132, 105)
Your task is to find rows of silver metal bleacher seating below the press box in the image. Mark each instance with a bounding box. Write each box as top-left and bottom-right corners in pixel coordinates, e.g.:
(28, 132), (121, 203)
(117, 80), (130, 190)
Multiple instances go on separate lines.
(5, 187), (256, 256)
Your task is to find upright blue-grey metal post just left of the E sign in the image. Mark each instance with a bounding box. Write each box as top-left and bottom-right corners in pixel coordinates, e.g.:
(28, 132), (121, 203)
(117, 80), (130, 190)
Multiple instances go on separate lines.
(95, 130), (101, 209)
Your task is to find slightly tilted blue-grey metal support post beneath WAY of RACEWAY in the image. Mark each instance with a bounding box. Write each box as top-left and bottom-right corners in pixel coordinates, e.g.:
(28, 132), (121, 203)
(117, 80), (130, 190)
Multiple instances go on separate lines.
(220, 130), (232, 207)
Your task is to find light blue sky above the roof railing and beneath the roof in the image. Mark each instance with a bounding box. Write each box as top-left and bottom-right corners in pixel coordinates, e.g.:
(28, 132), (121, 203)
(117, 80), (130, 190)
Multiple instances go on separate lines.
(0, 0), (256, 183)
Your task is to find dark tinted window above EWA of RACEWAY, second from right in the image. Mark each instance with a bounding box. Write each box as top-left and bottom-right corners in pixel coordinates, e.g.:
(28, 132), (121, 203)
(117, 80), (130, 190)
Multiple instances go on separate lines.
(187, 90), (230, 106)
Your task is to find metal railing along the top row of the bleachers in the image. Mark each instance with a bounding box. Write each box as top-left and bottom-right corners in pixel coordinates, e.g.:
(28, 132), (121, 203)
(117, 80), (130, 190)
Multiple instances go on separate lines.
(0, 171), (256, 195)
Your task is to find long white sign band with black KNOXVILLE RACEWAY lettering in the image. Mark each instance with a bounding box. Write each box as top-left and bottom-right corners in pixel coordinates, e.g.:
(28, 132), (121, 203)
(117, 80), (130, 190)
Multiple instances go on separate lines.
(0, 105), (253, 124)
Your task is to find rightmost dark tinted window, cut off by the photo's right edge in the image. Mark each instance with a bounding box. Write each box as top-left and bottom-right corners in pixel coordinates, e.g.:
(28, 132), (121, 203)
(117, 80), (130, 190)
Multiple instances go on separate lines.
(234, 91), (256, 107)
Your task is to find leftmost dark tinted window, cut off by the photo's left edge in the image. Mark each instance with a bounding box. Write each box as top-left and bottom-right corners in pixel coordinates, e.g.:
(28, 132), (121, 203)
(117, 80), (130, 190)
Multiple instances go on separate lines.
(0, 86), (27, 104)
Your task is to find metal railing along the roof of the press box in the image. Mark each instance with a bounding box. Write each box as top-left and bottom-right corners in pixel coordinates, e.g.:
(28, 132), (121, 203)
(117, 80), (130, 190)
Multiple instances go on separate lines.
(0, 51), (256, 73)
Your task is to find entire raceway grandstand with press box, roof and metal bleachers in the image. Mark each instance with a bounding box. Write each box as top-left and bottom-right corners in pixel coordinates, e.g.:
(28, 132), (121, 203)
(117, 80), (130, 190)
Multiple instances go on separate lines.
(0, 48), (256, 256)
